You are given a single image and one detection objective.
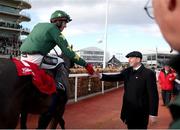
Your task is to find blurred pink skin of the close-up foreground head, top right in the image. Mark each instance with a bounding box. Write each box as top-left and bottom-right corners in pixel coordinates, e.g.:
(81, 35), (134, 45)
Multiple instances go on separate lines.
(152, 0), (180, 51)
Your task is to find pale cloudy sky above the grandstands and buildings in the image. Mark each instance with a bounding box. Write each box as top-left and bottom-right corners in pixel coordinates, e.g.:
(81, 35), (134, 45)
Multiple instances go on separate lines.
(23, 0), (170, 61)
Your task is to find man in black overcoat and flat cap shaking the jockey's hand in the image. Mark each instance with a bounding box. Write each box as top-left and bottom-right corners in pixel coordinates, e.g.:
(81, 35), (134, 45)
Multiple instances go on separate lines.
(97, 51), (159, 129)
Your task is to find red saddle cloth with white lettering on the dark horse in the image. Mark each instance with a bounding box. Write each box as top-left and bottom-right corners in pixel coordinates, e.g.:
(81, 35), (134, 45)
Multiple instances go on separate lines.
(12, 58), (56, 95)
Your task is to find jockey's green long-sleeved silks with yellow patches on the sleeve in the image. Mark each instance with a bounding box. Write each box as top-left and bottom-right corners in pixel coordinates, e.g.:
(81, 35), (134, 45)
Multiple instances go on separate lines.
(20, 23), (86, 66)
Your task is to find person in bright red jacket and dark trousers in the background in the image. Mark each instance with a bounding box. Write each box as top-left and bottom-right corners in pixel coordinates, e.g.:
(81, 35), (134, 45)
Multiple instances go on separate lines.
(158, 65), (176, 106)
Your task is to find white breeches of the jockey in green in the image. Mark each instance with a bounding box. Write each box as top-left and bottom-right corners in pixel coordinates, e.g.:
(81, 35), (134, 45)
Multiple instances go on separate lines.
(21, 54), (64, 69)
